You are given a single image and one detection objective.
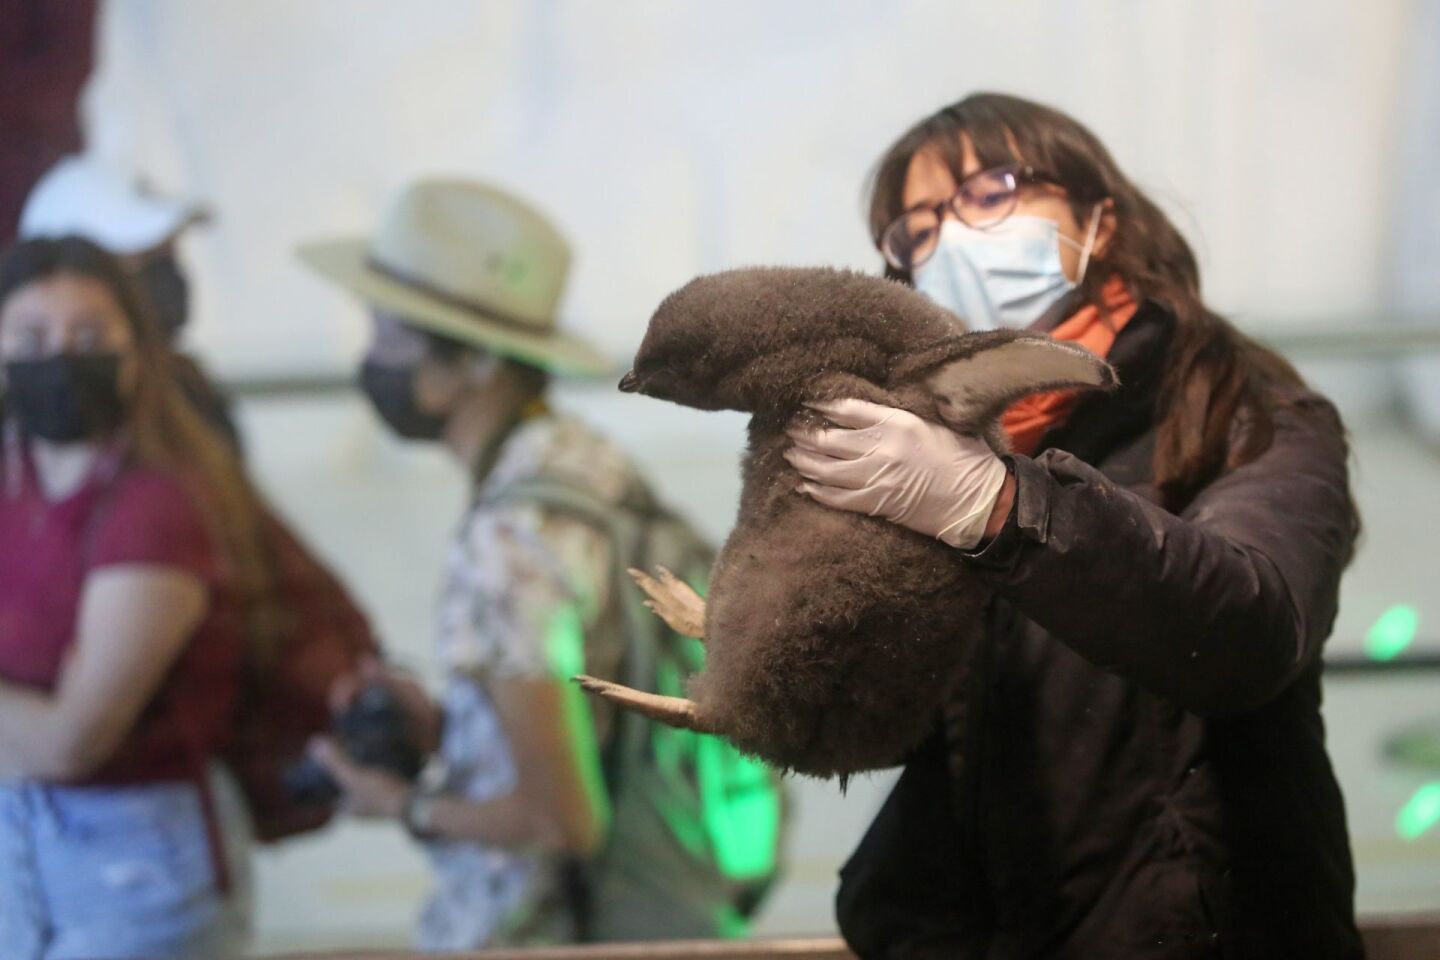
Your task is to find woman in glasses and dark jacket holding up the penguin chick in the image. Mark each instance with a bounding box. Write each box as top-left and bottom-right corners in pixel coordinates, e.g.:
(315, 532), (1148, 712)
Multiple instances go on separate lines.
(789, 94), (1362, 960)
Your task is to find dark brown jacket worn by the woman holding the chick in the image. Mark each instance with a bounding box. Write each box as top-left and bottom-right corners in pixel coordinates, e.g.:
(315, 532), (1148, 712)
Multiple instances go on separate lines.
(837, 305), (1362, 960)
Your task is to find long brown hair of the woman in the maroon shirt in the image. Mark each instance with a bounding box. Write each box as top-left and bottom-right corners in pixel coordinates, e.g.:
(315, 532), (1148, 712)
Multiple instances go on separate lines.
(0, 236), (271, 653)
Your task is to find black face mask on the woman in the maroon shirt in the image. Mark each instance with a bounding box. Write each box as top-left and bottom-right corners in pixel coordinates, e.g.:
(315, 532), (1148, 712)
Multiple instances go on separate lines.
(4, 353), (124, 443)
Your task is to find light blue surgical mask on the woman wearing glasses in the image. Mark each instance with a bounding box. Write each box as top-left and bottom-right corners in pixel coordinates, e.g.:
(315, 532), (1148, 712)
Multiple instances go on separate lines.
(914, 203), (1102, 330)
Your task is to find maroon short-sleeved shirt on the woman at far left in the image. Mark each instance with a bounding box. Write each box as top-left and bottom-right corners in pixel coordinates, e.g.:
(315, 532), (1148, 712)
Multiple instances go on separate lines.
(0, 446), (243, 783)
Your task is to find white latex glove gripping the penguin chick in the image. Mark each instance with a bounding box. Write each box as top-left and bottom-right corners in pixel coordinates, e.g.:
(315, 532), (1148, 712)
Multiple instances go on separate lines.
(785, 400), (1005, 550)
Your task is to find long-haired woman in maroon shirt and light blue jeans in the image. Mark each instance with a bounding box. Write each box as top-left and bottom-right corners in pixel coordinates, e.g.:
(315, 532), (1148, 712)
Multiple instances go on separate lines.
(0, 237), (265, 960)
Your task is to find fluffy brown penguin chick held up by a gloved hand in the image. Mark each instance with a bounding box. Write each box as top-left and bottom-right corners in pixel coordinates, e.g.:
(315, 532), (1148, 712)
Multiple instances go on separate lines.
(580, 268), (1115, 777)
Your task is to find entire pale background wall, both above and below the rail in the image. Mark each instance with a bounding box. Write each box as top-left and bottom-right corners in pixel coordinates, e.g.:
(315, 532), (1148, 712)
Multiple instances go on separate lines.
(88, 0), (1433, 946)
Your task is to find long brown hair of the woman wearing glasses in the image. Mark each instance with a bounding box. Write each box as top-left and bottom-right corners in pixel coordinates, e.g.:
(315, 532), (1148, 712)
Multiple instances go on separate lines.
(870, 94), (1341, 510)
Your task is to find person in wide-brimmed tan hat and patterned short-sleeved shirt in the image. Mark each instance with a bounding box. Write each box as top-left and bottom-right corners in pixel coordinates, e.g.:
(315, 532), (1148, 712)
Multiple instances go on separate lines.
(301, 180), (760, 950)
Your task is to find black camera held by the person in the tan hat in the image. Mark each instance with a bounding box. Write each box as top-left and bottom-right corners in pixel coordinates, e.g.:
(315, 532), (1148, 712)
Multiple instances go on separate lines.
(284, 684), (425, 806)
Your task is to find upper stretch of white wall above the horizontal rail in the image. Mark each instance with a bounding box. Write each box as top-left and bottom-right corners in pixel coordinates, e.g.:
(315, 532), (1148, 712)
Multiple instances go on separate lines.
(89, 0), (1410, 371)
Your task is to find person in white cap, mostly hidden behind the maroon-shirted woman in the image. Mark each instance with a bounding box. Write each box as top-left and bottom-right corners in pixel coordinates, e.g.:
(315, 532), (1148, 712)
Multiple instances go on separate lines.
(20, 155), (240, 450)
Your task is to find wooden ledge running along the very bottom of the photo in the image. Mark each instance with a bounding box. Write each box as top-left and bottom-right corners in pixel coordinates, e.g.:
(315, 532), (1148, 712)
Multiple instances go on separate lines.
(267, 914), (1440, 960)
